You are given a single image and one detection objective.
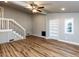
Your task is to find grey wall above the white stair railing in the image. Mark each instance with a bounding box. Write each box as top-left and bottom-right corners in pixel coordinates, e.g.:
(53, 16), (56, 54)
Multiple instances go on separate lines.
(3, 6), (32, 34)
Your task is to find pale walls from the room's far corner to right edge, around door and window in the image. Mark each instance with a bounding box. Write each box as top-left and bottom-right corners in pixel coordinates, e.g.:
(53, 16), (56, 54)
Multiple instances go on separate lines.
(33, 13), (79, 43)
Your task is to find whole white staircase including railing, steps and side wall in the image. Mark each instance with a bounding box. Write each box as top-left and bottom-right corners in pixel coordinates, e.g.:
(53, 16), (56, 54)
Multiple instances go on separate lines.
(0, 18), (26, 43)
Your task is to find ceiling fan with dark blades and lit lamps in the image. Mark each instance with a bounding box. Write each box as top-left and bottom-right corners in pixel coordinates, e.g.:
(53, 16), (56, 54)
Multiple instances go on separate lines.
(27, 2), (45, 13)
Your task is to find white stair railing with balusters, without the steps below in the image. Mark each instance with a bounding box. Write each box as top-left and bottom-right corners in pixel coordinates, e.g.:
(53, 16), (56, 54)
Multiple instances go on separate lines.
(0, 18), (26, 37)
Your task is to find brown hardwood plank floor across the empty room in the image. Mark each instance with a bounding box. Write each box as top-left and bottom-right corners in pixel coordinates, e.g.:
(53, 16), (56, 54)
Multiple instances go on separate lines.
(0, 36), (79, 57)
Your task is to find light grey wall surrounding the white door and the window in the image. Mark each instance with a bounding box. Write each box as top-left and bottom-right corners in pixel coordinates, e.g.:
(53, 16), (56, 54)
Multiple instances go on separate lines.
(46, 13), (79, 43)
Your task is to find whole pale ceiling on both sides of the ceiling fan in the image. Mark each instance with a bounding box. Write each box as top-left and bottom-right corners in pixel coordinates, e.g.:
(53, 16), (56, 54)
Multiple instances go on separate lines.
(1, 1), (79, 13)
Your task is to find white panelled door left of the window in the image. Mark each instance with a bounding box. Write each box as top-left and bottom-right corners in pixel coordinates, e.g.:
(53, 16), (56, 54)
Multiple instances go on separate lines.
(49, 19), (59, 39)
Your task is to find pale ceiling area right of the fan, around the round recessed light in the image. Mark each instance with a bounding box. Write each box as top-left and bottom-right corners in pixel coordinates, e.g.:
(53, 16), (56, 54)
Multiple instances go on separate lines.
(33, 1), (79, 13)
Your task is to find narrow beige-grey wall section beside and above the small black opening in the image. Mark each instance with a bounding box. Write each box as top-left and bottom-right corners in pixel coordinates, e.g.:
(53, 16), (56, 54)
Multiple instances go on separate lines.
(33, 14), (46, 36)
